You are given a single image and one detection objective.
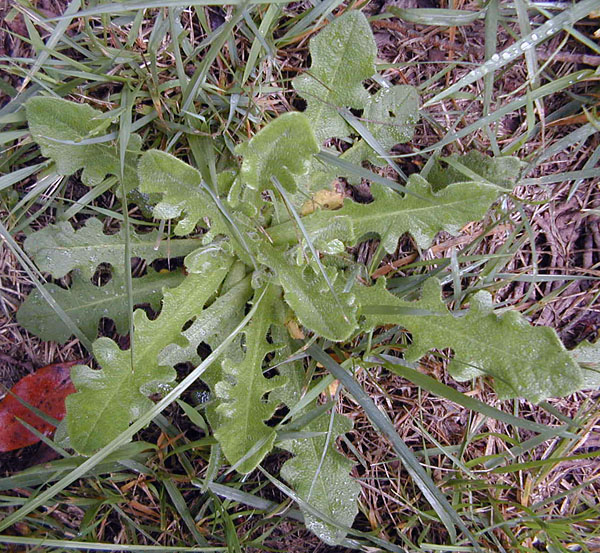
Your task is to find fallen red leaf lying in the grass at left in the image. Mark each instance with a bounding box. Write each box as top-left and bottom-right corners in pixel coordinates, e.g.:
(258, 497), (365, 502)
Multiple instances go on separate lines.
(0, 361), (81, 451)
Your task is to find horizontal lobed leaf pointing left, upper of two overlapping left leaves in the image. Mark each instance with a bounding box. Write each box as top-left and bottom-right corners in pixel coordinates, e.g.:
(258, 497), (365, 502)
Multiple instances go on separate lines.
(24, 217), (199, 278)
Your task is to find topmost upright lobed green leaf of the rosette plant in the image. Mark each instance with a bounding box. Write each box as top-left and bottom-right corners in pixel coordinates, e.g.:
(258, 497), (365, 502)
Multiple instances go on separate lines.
(293, 11), (377, 143)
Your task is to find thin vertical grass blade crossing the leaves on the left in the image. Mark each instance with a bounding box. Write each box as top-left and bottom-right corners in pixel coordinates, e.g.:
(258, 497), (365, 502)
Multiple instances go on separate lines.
(119, 86), (135, 360)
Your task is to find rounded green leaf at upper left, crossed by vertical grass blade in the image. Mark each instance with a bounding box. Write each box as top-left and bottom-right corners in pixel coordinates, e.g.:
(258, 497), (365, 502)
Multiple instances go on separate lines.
(25, 97), (142, 190)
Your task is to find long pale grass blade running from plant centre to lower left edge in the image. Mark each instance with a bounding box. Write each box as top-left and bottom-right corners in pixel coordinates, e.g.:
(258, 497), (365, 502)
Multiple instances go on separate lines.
(0, 286), (264, 528)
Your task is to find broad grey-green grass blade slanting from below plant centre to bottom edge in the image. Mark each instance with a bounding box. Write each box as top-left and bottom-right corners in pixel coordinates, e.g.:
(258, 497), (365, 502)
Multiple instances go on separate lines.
(307, 344), (481, 551)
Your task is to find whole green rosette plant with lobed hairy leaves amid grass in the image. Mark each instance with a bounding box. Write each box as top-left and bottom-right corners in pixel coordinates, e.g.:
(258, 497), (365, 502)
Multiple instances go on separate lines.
(19, 11), (596, 544)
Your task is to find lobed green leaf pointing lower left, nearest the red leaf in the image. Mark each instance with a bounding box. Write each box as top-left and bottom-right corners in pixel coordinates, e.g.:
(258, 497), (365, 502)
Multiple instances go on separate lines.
(66, 250), (231, 455)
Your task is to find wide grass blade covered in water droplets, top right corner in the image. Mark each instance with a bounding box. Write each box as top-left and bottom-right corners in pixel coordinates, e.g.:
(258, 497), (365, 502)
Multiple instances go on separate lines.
(423, 0), (598, 108)
